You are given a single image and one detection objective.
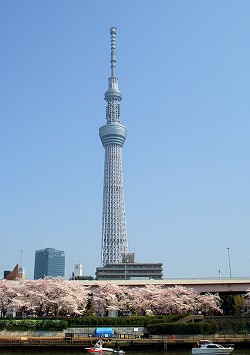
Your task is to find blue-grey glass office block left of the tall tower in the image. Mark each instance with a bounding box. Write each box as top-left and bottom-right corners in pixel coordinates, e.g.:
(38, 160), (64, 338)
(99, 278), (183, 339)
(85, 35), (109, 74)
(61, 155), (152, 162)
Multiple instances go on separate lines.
(34, 248), (65, 280)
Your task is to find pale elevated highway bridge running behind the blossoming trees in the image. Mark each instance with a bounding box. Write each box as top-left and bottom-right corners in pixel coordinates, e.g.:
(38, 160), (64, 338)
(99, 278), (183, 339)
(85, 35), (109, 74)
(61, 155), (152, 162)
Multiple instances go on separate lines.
(82, 277), (250, 294)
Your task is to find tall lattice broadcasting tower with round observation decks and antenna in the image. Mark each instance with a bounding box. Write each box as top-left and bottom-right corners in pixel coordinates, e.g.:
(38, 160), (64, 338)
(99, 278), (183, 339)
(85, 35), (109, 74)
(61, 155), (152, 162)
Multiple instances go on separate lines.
(99, 27), (128, 266)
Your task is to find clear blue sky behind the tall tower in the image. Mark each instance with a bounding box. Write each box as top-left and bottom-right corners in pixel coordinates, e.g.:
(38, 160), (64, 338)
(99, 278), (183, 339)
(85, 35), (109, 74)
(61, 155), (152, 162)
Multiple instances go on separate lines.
(0, 0), (250, 278)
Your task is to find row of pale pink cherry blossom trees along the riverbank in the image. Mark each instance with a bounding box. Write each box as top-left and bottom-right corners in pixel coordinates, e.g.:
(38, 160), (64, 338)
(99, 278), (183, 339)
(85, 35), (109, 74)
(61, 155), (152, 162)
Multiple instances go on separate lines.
(0, 278), (221, 317)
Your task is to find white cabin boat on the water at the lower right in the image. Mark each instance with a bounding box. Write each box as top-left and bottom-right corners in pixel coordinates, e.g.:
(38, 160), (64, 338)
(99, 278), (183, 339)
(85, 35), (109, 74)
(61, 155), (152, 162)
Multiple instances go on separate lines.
(192, 340), (234, 355)
